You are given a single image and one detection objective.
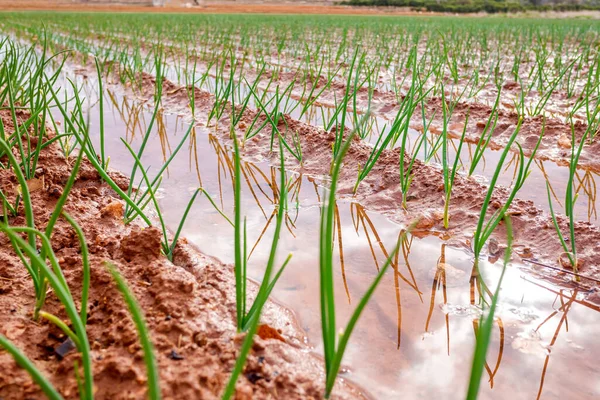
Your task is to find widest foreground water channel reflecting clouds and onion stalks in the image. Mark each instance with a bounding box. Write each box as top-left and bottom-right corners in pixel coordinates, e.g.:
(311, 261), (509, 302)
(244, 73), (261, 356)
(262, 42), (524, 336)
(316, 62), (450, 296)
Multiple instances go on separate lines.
(57, 74), (600, 399)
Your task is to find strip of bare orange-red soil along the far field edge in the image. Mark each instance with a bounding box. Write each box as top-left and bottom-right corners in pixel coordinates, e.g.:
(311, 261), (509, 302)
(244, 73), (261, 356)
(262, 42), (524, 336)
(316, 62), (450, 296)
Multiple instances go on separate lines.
(0, 0), (438, 15)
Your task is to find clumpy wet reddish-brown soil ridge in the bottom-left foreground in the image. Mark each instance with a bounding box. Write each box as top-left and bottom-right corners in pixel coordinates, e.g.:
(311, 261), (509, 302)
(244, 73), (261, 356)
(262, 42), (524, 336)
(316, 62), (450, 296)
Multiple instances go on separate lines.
(0, 111), (364, 400)
